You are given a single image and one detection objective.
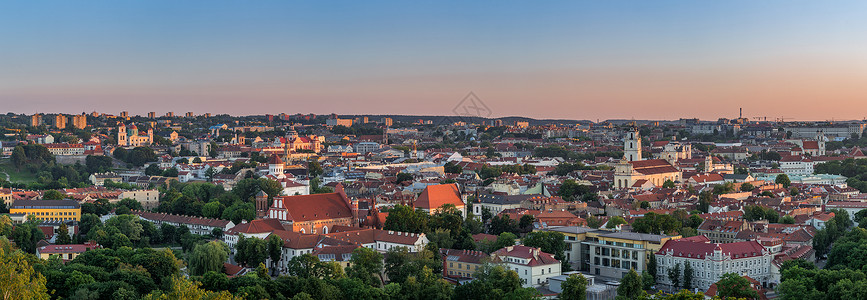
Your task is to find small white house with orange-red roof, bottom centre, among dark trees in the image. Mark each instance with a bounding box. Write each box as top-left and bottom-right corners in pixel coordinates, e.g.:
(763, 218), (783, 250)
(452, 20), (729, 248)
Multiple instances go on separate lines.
(491, 245), (560, 287)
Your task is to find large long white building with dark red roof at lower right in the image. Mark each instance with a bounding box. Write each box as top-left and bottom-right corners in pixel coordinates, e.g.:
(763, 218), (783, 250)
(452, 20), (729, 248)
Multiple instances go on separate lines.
(656, 237), (774, 290)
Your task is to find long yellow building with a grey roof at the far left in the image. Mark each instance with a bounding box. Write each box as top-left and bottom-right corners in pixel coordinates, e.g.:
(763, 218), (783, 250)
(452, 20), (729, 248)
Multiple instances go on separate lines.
(9, 200), (81, 222)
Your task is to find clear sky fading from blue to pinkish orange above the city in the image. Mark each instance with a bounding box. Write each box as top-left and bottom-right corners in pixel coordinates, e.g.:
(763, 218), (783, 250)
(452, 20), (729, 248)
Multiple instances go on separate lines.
(0, 0), (867, 121)
